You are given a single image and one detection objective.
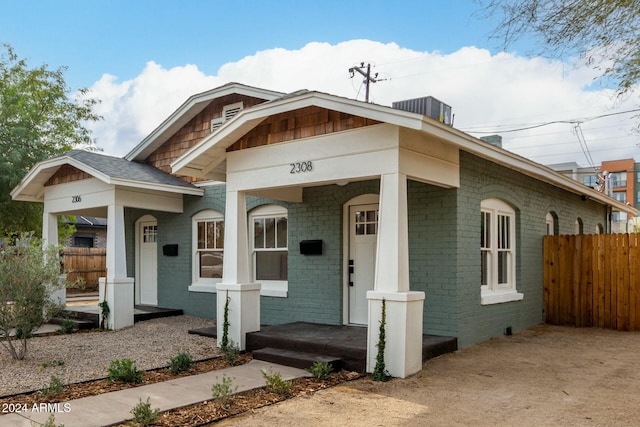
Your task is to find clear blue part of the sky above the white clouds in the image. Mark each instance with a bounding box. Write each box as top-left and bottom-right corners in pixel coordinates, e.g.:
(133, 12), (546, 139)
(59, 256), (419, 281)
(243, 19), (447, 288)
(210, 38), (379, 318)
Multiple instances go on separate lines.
(0, 0), (516, 88)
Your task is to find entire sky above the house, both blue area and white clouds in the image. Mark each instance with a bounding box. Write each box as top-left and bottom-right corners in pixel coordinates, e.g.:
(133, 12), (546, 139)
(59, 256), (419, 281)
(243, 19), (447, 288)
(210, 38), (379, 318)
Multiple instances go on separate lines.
(0, 0), (640, 166)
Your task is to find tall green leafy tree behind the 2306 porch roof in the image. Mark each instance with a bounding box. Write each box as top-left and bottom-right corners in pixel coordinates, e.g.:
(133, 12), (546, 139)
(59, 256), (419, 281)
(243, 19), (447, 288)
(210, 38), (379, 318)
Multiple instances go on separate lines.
(0, 44), (100, 234)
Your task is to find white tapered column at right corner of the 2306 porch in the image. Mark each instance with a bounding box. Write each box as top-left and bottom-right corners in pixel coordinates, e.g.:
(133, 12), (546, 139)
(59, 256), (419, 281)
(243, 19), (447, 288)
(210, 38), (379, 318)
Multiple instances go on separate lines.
(100, 204), (134, 329)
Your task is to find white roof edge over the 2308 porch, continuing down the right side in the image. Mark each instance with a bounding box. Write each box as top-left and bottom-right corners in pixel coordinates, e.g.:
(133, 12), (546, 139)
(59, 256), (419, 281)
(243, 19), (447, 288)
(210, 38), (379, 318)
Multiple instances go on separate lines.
(171, 91), (638, 215)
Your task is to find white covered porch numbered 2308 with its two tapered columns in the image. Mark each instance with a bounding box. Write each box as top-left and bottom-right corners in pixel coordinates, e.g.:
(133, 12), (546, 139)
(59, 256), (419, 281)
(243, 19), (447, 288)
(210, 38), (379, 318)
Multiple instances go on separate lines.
(171, 93), (459, 377)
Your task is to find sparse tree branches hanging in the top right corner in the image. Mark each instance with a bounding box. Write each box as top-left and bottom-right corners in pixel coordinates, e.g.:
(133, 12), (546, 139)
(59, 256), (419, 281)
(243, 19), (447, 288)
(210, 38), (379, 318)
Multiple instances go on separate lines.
(482, 0), (640, 95)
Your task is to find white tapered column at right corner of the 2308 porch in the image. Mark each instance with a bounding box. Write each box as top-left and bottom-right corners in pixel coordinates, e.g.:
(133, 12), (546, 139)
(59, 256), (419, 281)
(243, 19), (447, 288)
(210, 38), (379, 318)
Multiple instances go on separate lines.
(367, 173), (425, 378)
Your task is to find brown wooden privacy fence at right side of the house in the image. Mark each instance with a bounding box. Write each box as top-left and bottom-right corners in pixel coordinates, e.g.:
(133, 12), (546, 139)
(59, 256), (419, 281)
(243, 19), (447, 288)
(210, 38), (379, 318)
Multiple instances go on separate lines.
(544, 233), (640, 331)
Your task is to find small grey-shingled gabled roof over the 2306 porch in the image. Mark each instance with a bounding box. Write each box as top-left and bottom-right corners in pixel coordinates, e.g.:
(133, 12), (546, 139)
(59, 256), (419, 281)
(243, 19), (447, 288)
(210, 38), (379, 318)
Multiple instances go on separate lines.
(11, 150), (202, 202)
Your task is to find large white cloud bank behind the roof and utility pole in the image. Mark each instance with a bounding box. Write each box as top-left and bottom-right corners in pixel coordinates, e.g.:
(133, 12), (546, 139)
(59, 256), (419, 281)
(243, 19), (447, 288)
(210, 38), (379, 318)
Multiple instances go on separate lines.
(82, 40), (638, 165)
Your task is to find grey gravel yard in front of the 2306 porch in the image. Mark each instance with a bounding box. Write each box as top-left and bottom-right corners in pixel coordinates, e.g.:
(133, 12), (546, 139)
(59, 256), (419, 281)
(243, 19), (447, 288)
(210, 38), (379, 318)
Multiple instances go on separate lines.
(0, 316), (220, 396)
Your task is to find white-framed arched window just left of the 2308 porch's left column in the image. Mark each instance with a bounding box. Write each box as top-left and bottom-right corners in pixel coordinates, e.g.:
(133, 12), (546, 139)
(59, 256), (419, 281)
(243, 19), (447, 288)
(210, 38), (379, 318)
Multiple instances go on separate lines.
(189, 210), (224, 292)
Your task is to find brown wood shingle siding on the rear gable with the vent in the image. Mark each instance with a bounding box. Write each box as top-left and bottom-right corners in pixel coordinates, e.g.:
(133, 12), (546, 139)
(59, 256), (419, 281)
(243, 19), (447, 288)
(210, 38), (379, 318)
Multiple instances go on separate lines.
(146, 94), (265, 182)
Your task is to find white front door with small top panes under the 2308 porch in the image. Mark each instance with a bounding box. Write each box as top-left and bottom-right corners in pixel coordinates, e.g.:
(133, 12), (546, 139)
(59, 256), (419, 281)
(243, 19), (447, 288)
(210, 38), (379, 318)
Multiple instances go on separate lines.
(348, 204), (378, 325)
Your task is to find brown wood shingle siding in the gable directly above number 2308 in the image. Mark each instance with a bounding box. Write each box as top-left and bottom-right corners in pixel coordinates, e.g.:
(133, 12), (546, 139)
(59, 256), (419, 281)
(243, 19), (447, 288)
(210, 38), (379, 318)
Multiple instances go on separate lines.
(227, 106), (380, 151)
